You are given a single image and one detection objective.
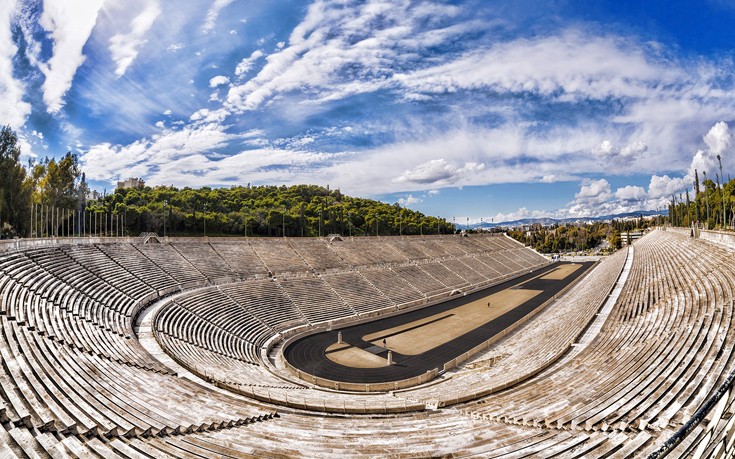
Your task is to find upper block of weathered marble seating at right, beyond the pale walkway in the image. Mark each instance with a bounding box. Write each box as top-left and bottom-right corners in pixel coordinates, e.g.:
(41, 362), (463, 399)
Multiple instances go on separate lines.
(466, 231), (735, 456)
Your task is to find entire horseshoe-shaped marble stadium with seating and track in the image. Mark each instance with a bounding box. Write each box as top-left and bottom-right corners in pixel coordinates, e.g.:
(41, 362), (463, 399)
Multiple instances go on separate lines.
(0, 228), (735, 458)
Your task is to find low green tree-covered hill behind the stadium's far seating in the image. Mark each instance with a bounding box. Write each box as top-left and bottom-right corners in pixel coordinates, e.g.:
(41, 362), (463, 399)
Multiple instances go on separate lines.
(93, 185), (454, 237)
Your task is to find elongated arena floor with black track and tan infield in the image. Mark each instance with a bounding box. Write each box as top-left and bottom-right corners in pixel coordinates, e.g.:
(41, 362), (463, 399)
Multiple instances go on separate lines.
(283, 262), (594, 392)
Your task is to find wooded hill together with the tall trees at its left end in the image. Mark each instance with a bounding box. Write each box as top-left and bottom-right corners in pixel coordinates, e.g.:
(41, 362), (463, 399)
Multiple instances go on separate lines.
(0, 126), (454, 237)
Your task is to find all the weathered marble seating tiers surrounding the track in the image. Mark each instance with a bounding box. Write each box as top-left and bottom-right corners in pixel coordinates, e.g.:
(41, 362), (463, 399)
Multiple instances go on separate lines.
(7, 233), (708, 458)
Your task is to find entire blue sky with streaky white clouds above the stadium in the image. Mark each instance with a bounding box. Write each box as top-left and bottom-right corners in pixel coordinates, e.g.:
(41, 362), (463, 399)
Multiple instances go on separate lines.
(0, 0), (735, 222)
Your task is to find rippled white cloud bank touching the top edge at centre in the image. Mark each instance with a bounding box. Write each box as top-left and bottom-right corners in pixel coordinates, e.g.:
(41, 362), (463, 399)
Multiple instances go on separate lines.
(227, 0), (484, 111)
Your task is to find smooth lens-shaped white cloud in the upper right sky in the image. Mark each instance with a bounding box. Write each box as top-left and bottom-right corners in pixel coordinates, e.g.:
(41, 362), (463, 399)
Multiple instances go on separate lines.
(396, 29), (687, 100)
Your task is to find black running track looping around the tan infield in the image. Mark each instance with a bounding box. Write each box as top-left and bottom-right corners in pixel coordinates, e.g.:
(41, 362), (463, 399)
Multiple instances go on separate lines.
(284, 262), (594, 384)
